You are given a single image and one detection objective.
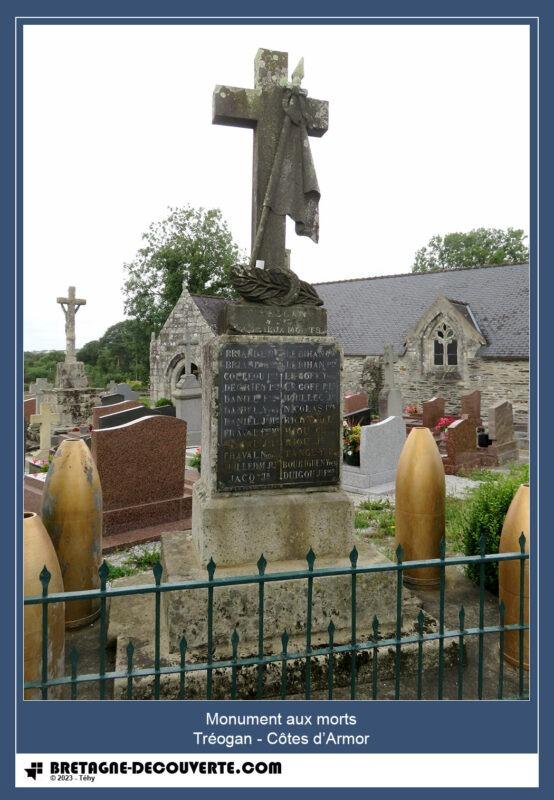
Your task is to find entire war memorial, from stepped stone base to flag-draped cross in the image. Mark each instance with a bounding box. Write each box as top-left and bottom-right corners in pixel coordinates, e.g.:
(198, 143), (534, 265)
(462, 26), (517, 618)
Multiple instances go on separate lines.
(155, 50), (402, 692)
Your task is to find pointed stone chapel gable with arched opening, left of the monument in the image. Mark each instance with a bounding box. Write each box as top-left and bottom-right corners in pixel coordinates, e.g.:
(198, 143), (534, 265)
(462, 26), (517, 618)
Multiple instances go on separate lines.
(150, 289), (214, 403)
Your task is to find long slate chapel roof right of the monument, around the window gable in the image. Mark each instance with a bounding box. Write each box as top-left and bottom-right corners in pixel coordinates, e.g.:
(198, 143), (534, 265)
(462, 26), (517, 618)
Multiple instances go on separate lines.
(314, 264), (529, 358)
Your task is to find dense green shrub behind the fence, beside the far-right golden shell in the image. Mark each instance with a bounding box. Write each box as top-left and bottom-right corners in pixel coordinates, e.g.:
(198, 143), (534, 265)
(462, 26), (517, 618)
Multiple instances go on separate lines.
(450, 464), (529, 594)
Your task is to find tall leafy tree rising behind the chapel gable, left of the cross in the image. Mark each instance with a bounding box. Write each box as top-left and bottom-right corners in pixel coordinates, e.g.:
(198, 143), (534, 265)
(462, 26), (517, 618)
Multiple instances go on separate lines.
(123, 206), (242, 330)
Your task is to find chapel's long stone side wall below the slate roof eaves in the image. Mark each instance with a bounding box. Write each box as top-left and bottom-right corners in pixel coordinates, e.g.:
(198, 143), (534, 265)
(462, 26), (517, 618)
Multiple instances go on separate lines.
(343, 352), (529, 423)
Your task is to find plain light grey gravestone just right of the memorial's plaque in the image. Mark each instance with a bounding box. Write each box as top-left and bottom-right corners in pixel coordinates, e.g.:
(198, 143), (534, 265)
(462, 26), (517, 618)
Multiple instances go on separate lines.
(342, 417), (406, 494)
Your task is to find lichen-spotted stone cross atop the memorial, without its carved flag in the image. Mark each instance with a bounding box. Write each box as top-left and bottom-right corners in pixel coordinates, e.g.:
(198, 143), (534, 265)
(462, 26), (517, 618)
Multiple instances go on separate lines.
(213, 49), (329, 269)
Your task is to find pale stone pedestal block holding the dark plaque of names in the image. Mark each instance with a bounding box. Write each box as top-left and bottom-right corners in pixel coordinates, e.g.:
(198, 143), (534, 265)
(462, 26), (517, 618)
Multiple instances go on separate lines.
(193, 332), (352, 566)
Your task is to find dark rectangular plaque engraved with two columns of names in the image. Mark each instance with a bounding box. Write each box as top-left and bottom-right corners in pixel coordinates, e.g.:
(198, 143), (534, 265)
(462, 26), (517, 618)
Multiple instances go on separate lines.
(217, 342), (341, 491)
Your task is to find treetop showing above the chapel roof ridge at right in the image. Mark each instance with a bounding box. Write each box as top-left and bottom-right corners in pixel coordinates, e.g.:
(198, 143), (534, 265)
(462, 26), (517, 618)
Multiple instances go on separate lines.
(412, 228), (529, 272)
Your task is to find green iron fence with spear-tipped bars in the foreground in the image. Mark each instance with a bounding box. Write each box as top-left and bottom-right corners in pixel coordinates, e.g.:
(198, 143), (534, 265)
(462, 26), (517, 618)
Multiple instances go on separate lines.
(24, 534), (529, 700)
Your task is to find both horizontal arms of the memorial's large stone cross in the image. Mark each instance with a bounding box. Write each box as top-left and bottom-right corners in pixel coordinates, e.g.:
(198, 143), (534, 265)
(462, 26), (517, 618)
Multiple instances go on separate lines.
(212, 86), (329, 137)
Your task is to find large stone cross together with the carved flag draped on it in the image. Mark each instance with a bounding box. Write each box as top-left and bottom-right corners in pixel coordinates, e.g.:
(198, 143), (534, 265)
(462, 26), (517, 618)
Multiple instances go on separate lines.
(213, 49), (329, 276)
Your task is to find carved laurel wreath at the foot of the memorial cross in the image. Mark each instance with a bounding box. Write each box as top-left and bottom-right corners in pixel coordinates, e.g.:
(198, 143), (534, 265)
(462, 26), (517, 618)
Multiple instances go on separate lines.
(231, 264), (323, 306)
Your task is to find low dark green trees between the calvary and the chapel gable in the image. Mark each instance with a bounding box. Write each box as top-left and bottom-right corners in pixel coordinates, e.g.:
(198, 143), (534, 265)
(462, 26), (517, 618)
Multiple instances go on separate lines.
(77, 319), (151, 389)
